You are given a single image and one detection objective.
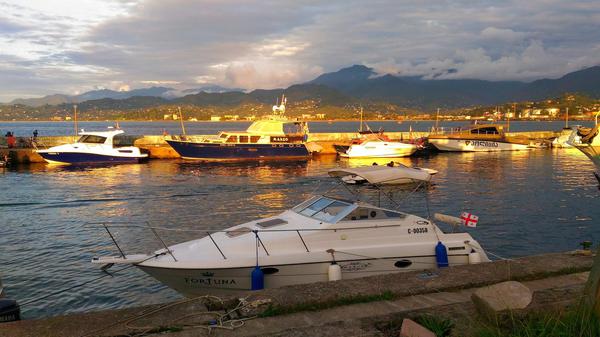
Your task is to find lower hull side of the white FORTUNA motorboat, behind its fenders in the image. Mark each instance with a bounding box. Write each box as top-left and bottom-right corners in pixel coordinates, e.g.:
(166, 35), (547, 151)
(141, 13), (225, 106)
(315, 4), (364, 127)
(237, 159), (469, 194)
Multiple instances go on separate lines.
(138, 254), (468, 296)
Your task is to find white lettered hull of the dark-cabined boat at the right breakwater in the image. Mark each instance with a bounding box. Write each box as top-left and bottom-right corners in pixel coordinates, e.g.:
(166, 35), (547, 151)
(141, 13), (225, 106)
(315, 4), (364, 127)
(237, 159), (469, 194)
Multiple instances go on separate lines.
(429, 138), (531, 152)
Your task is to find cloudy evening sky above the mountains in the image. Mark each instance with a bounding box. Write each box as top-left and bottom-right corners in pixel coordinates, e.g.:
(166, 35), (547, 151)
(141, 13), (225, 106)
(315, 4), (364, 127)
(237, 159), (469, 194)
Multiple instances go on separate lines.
(0, 0), (600, 102)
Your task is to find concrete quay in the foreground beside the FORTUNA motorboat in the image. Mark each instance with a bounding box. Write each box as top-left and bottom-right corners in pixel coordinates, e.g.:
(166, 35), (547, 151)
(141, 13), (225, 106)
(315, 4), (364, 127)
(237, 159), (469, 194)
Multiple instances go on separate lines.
(0, 253), (593, 337)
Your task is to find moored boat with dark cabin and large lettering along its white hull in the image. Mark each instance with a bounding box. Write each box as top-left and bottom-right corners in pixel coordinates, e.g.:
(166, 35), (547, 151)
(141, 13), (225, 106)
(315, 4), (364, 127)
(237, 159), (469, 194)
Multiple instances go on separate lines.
(428, 124), (531, 152)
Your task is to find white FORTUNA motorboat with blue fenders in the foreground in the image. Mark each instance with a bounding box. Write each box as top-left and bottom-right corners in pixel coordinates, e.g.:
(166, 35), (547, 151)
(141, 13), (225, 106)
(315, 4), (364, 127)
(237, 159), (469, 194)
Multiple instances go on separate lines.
(92, 170), (489, 296)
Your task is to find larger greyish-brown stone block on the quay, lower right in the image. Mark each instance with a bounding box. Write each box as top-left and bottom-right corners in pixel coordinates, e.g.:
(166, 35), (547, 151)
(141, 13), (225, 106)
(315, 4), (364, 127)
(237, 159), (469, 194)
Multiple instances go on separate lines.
(471, 281), (533, 321)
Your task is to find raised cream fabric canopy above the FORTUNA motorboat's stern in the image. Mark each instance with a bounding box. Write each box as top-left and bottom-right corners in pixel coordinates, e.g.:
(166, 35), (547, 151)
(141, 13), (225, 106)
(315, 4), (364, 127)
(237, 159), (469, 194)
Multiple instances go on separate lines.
(329, 163), (438, 185)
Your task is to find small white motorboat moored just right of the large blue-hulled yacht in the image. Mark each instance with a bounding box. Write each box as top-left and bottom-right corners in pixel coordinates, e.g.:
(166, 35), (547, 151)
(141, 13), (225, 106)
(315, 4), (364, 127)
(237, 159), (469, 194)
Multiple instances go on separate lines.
(340, 139), (417, 158)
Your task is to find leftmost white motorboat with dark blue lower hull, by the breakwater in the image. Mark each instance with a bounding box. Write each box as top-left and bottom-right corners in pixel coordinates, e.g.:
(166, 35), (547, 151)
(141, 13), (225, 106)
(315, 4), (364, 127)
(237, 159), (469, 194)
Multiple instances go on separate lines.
(36, 130), (148, 164)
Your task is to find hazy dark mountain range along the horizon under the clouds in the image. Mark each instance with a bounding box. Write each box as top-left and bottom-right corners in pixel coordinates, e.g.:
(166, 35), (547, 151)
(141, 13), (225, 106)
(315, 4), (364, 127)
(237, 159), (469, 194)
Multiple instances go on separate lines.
(4, 65), (600, 110)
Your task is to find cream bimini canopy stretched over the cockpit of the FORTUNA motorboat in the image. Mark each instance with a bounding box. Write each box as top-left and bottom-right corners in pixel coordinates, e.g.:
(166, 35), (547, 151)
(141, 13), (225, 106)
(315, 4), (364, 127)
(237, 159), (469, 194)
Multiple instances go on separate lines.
(328, 165), (431, 185)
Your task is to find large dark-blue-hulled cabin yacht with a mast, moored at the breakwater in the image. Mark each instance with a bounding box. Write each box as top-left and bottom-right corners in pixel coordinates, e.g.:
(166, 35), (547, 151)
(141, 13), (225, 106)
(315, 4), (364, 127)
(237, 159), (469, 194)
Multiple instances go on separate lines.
(165, 97), (313, 160)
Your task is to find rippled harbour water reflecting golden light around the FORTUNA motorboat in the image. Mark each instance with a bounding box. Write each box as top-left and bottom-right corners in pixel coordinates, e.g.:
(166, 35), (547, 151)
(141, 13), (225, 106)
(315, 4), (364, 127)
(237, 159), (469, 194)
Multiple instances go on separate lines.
(0, 124), (600, 318)
